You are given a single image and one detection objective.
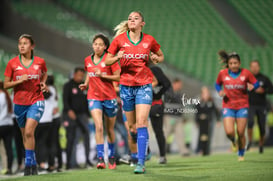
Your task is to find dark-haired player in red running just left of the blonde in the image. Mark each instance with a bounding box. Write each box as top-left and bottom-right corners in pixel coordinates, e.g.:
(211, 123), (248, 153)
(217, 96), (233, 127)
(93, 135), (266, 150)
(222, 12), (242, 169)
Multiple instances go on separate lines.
(79, 34), (120, 169)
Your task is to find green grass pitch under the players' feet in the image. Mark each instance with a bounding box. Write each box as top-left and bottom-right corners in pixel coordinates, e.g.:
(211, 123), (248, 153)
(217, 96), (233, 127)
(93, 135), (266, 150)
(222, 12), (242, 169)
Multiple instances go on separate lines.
(1, 148), (273, 181)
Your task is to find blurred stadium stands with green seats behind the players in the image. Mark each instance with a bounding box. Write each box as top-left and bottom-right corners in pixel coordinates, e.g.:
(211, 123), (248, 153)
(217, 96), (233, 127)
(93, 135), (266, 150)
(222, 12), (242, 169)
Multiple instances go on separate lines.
(0, 0), (273, 159)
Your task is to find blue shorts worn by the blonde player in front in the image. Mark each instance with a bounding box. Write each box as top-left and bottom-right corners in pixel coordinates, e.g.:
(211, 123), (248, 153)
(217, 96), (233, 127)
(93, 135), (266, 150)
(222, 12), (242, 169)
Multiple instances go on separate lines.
(120, 84), (153, 111)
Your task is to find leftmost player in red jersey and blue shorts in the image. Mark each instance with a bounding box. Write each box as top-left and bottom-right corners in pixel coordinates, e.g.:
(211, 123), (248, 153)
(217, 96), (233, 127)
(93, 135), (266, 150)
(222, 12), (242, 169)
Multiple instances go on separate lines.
(4, 34), (47, 175)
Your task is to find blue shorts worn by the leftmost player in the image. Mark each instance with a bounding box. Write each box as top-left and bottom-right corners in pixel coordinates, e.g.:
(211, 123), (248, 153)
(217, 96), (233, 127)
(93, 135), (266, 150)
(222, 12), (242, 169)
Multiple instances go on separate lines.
(14, 101), (45, 128)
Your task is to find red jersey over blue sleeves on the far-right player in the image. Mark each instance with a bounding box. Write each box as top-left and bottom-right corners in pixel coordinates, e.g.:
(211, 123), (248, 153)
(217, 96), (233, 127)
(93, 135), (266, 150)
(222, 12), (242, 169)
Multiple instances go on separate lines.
(216, 69), (257, 110)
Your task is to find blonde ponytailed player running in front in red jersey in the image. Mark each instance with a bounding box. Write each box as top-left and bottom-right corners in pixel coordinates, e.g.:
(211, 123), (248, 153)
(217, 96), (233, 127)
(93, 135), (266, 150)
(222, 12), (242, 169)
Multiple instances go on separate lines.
(105, 12), (164, 173)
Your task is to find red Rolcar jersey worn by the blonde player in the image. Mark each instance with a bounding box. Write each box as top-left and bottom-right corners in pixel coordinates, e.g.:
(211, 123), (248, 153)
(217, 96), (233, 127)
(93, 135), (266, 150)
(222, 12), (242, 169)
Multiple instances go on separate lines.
(108, 31), (160, 86)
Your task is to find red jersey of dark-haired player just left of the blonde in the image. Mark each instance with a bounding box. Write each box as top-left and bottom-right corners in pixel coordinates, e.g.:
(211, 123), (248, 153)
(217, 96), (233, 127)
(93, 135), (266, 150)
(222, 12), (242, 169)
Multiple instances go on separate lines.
(84, 53), (120, 101)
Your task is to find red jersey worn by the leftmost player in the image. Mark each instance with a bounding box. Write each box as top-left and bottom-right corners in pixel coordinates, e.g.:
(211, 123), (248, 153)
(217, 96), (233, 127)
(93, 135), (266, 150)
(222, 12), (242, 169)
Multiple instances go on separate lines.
(4, 55), (47, 105)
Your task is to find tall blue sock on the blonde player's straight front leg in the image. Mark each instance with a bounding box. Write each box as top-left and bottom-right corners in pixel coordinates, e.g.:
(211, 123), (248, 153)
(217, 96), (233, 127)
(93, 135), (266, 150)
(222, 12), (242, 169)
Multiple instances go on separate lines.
(137, 127), (149, 165)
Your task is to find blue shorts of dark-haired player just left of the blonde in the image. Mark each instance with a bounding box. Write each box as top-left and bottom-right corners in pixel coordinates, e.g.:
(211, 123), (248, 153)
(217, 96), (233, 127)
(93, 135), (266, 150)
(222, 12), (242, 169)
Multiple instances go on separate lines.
(88, 99), (118, 118)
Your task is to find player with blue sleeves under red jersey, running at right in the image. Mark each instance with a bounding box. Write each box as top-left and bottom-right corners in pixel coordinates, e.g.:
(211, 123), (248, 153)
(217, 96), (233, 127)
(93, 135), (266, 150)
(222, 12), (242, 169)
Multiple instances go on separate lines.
(215, 51), (259, 161)
